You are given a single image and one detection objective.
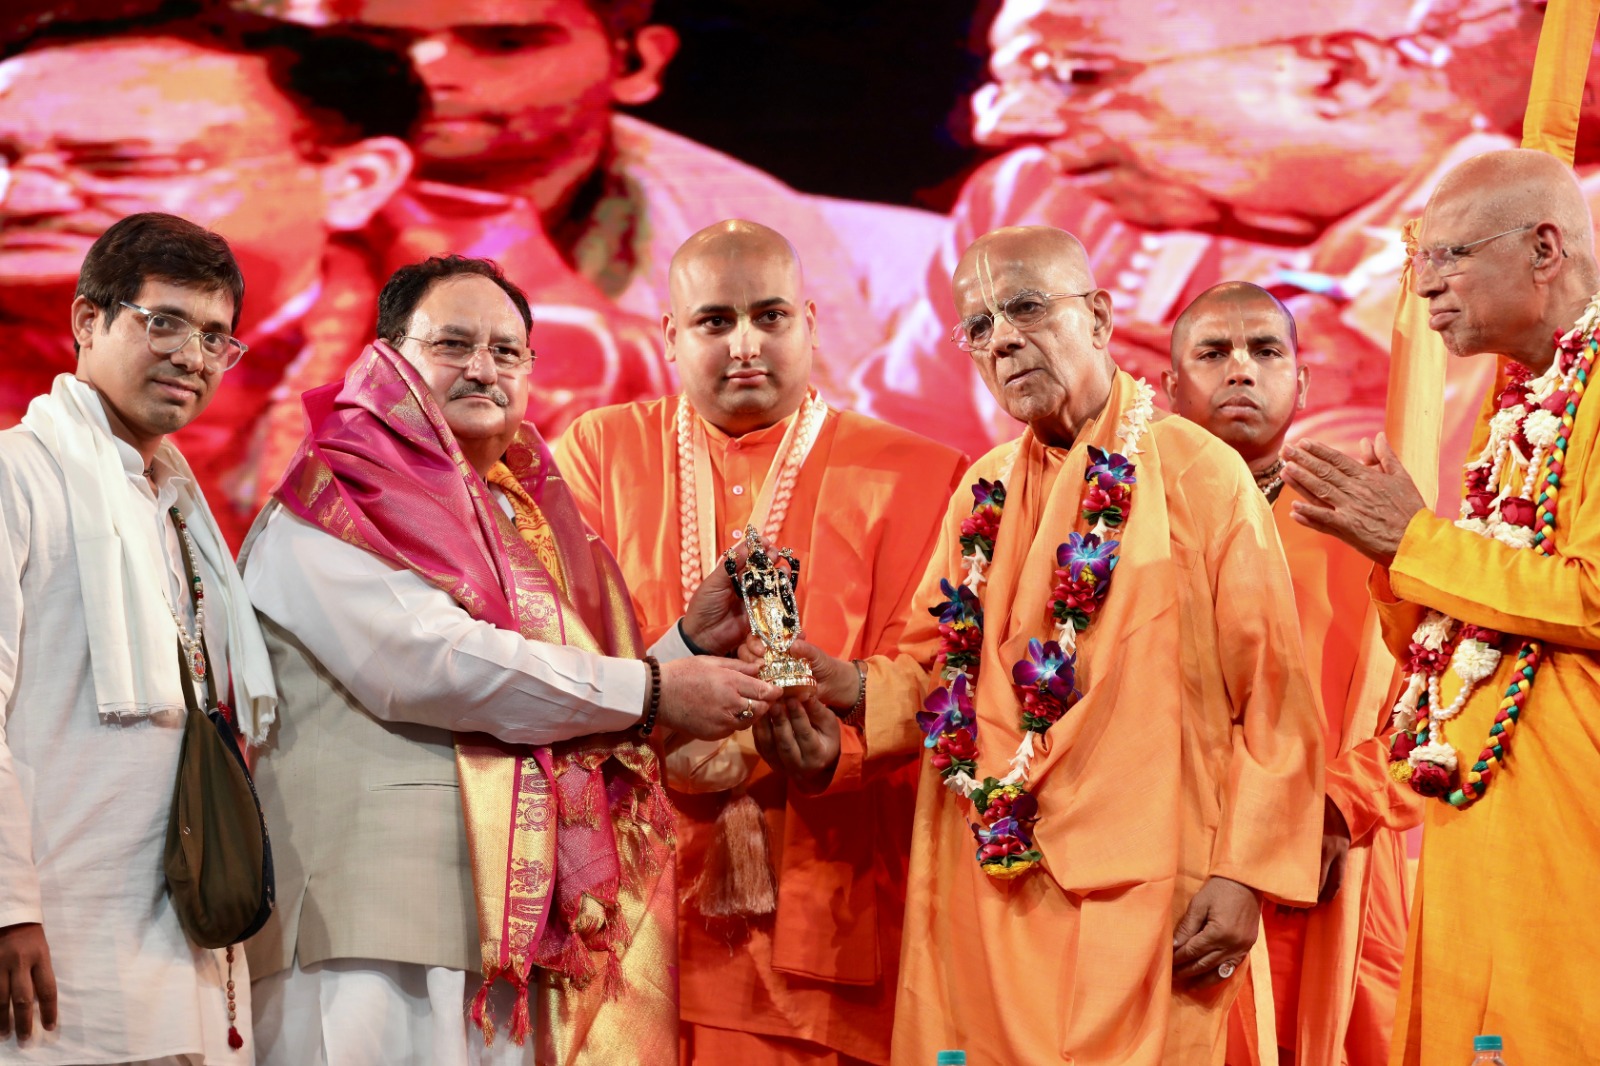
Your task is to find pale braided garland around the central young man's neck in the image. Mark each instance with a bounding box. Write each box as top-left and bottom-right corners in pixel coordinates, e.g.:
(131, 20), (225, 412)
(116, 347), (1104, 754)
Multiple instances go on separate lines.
(675, 394), (827, 608)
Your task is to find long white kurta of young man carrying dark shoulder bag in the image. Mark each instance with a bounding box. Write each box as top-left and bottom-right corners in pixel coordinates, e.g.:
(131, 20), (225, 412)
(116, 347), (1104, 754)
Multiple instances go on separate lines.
(0, 377), (253, 1066)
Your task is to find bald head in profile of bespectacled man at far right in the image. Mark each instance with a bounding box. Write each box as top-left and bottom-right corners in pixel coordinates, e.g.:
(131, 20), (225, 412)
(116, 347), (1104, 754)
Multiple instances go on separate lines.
(1411, 149), (1600, 371)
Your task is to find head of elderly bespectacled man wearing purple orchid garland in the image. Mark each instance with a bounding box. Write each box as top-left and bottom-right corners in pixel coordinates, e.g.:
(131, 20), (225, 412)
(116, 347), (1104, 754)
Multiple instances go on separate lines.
(952, 226), (1117, 447)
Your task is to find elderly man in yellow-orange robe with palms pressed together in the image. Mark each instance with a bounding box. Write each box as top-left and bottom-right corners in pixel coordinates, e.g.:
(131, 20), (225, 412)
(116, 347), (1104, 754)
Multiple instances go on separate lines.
(1285, 150), (1600, 1066)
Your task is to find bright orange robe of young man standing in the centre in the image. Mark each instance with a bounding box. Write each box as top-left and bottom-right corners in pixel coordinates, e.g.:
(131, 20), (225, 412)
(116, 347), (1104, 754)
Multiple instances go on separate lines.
(557, 397), (965, 1066)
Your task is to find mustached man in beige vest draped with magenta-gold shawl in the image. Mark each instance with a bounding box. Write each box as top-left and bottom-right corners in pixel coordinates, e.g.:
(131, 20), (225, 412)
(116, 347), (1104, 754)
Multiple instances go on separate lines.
(246, 256), (778, 1066)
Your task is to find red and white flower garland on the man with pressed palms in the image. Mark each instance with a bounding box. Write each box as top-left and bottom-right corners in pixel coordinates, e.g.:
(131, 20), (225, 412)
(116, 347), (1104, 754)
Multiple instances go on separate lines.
(1389, 295), (1600, 808)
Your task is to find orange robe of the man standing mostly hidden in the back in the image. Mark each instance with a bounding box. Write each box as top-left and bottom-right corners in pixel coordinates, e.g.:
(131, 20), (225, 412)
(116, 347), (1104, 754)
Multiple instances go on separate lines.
(1264, 487), (1422, 1066)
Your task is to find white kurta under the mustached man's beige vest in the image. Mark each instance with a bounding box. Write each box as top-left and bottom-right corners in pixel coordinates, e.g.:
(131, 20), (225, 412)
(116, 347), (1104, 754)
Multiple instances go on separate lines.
(245, 499), (688, 1066)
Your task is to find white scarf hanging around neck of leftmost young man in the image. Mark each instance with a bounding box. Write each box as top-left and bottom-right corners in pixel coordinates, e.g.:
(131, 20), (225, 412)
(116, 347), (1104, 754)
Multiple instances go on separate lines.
(22, 375), (278, 744)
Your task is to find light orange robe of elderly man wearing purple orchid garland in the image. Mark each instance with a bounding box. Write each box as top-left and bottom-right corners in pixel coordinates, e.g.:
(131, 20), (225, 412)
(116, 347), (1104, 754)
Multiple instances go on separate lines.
(838, 373), (1323, 1066)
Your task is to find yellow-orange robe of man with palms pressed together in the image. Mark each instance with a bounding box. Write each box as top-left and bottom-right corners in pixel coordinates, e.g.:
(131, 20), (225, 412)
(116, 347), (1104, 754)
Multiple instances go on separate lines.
(1371, 358), (1600, 1066)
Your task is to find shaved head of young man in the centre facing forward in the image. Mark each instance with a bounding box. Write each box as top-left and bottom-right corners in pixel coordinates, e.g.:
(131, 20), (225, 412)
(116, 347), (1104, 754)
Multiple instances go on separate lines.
(661, 219), (818, 435)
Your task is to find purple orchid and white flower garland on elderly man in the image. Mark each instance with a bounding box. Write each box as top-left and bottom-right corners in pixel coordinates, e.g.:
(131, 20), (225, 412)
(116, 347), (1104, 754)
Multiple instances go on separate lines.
(917, 381), (1155, 880)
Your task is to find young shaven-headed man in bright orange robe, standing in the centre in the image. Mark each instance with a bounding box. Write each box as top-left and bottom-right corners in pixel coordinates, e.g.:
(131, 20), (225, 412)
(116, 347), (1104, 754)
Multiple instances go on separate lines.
(558, 221), (966, 1066)
